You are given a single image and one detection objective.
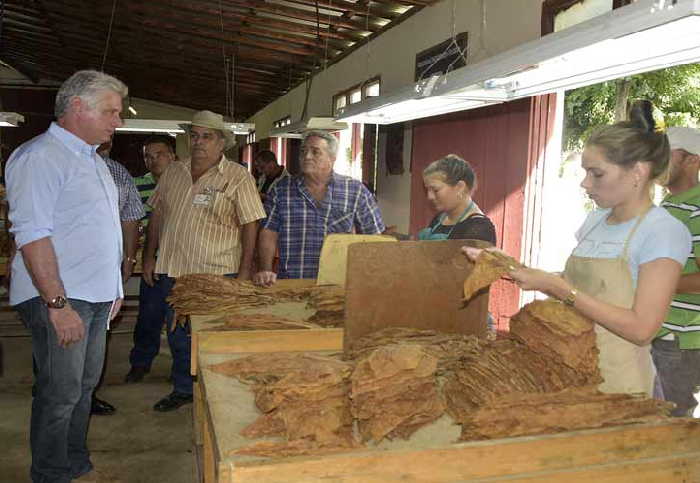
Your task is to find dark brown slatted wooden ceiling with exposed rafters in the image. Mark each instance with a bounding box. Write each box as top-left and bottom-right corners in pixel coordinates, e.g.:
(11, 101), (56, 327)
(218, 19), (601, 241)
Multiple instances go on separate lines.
(0, 0), (436, 119)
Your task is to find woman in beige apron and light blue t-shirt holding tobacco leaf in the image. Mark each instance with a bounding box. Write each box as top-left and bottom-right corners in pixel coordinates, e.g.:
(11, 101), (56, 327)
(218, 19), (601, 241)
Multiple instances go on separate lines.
(463, 104), (691, 395)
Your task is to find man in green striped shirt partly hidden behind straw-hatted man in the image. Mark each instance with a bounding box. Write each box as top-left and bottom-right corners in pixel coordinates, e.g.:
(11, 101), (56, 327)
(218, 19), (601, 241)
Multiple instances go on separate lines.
(126, 136), (175, 382)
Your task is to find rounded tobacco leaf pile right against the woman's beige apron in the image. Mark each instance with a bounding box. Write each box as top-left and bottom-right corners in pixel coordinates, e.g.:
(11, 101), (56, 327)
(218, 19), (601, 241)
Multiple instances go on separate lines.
(510, 299), (602, 384)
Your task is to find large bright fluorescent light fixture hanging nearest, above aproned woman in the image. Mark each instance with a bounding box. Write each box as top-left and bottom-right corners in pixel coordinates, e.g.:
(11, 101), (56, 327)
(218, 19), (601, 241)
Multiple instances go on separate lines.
(338, 0), (700, 124)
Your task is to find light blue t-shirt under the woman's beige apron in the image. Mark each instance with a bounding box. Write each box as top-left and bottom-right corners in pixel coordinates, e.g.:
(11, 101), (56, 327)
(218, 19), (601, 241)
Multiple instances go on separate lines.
(574, 206), (692, 286)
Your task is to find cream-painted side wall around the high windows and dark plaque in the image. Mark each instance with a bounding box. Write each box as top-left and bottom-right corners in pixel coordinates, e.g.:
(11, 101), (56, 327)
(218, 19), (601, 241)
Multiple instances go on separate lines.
(249, 0), (542, 232)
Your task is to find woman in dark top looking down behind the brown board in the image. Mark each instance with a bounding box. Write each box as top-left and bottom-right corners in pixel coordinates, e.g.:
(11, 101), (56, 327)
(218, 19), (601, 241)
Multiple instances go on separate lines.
(418, 154), (496, 244)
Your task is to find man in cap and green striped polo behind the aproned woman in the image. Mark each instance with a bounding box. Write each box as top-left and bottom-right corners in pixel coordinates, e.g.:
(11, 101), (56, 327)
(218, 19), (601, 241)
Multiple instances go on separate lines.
(652, 127), (700, 416)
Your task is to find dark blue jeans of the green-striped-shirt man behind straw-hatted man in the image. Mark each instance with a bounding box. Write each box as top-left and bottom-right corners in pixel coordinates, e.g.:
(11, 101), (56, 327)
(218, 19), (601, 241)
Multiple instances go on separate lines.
(129, 276), (173, 369)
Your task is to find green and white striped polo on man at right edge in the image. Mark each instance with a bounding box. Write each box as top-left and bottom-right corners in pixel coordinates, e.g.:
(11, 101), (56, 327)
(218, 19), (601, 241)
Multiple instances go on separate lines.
(657, 184), (700, 349)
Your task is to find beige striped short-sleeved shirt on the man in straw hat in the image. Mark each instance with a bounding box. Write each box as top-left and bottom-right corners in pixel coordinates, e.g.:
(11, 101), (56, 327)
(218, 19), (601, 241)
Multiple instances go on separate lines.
(148, 156), (265, 277)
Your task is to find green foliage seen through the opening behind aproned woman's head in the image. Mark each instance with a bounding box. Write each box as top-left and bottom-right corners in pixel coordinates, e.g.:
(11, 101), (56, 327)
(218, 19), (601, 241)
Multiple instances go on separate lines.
(562, 64), (700, 152)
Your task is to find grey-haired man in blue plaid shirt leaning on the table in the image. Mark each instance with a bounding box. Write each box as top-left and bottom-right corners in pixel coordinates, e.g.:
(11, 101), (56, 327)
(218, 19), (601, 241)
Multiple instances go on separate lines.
(253, 131), (385, 286)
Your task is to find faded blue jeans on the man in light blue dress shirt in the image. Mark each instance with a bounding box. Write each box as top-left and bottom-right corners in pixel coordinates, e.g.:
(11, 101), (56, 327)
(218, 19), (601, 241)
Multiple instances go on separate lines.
(16, 297), (111, 483)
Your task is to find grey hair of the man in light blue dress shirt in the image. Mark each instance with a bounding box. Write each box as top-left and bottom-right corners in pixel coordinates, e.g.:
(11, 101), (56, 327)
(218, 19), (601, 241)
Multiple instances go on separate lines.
(54, 70), (129, 119)
